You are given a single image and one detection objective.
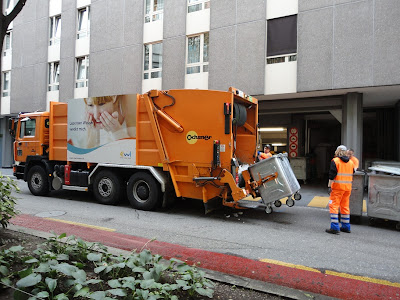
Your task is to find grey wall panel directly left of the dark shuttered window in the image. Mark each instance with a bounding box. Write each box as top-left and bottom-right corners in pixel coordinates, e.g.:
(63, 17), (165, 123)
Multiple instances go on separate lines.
(209, 0), (266, 94)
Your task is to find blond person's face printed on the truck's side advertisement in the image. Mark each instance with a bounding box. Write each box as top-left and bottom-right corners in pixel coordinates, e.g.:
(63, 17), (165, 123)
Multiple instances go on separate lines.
(84, 96), (119, 125)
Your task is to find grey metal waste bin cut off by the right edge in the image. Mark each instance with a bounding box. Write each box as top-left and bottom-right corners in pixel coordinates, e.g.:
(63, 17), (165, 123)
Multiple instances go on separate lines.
(367, 173), (400, 229)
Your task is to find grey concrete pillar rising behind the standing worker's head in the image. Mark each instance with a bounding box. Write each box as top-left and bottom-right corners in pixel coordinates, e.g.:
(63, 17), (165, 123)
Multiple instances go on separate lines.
(342, 93), (363, 168)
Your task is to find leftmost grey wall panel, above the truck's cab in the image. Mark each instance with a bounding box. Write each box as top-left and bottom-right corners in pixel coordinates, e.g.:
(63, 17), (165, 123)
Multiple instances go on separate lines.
(11, 0), (49, 113)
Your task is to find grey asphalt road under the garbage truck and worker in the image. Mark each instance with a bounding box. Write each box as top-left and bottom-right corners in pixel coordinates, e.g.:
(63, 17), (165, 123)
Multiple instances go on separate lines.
(12, 180), (400, 283)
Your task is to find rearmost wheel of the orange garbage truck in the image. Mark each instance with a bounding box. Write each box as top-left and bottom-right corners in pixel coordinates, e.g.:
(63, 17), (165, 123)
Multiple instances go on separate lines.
(127, 172), (161, 210)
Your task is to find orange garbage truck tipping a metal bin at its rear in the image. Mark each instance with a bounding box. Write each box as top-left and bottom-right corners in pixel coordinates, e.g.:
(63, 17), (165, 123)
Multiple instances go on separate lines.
(14, 88), (300, 212)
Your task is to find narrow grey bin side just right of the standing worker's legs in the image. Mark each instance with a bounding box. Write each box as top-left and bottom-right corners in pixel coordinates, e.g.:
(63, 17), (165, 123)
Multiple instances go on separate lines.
(349, 171), (365, 223)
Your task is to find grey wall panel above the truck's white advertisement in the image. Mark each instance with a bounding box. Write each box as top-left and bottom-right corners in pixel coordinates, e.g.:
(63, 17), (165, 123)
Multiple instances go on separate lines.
(89, 0), (144, 96)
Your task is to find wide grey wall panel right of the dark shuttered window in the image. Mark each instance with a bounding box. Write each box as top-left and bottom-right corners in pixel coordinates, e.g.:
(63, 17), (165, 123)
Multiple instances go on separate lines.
(297, 0), (400, 92)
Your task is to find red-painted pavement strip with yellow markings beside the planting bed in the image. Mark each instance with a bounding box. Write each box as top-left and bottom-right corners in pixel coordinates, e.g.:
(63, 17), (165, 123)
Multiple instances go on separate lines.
(10, 215), (400, 299)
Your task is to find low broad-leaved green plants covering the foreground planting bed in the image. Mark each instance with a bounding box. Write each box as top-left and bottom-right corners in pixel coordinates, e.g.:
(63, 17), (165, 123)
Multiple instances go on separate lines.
(0, 234), (214, 300)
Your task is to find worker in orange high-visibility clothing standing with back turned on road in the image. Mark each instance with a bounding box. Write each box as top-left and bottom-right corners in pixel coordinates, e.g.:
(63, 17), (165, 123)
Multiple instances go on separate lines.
(326, 145), (354, 234)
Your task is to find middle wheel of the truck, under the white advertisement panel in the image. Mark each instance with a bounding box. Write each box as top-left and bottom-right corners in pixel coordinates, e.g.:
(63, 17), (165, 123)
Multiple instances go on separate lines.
(93, 170), (123, 205)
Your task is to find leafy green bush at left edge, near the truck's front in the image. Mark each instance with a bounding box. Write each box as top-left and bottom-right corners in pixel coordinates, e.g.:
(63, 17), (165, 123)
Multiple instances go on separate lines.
(0, 174), (19, 228)
